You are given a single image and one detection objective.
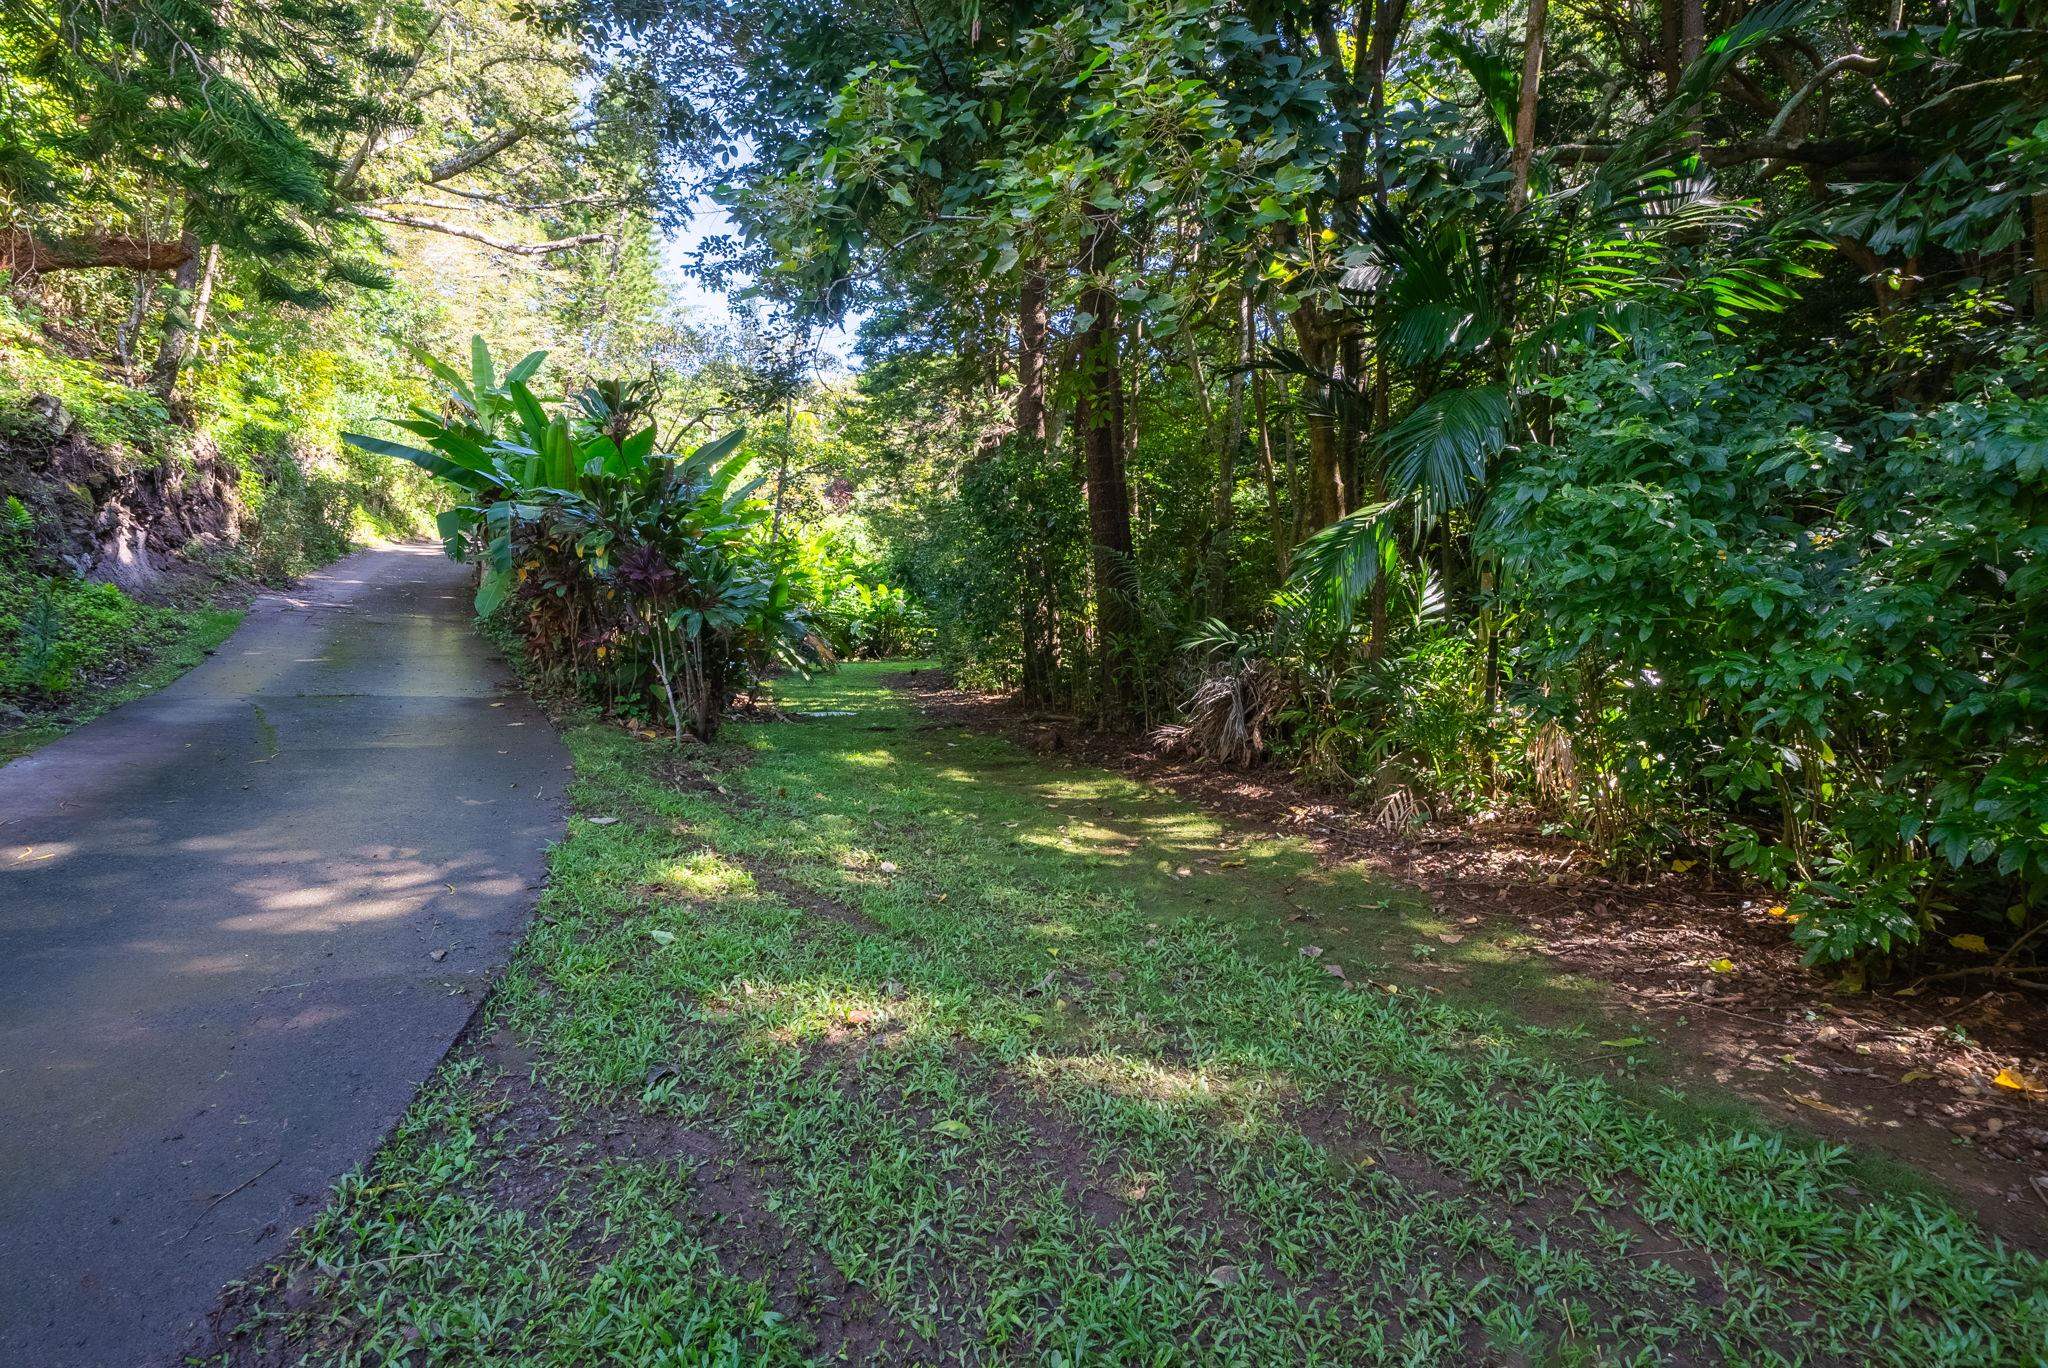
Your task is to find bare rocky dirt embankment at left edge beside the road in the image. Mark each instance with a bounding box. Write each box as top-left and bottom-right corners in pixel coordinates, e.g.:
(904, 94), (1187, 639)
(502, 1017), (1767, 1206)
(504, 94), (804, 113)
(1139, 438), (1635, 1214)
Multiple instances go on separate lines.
(0, 395), (242, 596)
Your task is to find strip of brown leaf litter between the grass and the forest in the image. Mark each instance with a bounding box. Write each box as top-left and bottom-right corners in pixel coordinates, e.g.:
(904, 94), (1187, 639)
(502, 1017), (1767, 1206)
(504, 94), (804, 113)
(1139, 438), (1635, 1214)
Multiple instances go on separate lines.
(889, 670), (2048, 1251)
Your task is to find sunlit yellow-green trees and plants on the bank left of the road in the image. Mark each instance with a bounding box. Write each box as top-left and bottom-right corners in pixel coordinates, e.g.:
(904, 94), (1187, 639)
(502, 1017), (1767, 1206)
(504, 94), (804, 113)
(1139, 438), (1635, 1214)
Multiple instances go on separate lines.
(0, 0), (723, 737)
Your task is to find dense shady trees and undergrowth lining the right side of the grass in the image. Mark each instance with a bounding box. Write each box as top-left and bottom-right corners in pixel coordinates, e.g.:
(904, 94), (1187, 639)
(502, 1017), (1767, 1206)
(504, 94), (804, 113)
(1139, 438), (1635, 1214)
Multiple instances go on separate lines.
(588, 0), (2048, 973)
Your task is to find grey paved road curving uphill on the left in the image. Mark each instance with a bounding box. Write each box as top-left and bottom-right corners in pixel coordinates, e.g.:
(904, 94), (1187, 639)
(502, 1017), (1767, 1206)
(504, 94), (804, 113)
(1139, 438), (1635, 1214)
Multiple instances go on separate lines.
(0, 547), (567, 1368)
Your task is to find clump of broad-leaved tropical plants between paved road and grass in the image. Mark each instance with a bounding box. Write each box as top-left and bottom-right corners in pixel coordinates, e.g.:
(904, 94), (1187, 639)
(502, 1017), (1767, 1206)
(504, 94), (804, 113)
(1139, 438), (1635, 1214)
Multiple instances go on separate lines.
(348, 336), (827, 741)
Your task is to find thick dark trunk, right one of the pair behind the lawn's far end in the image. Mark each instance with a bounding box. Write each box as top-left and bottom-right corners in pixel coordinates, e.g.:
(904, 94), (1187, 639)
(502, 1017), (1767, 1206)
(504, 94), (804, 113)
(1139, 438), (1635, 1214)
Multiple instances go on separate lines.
(1075, 213), (1139, 727)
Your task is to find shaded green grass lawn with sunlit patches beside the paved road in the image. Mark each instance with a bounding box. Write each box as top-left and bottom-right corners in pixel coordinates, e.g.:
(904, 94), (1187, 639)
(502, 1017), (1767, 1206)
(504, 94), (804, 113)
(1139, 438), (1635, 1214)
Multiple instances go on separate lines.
(211, 666), (2048, 1364)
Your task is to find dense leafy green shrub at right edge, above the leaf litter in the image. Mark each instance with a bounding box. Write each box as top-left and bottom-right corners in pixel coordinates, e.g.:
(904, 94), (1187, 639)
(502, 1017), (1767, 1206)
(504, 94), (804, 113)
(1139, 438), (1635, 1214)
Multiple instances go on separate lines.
(1493, 323), (2048, 963)
